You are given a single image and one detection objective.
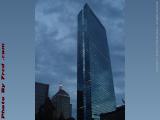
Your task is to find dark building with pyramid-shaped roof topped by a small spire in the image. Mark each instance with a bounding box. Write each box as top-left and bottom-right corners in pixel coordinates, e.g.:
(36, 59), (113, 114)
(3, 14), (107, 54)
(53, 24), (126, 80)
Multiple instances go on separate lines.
(52, 85), (72, 119)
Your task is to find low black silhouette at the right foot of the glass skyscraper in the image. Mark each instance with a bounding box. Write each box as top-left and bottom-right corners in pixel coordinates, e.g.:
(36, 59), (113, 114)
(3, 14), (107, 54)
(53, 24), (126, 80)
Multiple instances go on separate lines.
(100, 105), (125, 120)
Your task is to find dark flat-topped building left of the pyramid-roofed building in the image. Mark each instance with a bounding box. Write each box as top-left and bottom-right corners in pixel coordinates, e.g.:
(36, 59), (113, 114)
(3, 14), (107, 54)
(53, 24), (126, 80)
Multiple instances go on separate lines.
(35, 82), (49, 113)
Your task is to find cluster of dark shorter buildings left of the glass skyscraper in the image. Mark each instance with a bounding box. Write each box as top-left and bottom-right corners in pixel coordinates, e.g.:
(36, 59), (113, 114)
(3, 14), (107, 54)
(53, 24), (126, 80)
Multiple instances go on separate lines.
(35, 82), (74, 120)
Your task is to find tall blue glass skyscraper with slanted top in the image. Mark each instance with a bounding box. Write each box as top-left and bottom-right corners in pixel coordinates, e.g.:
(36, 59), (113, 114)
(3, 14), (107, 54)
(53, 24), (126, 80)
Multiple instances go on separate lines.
(77, 4), (116, 120)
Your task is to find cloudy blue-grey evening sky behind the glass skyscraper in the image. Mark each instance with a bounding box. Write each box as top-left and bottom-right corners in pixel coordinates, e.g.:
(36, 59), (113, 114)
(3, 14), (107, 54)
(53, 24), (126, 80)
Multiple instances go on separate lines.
(35, 0), (125, 116)
